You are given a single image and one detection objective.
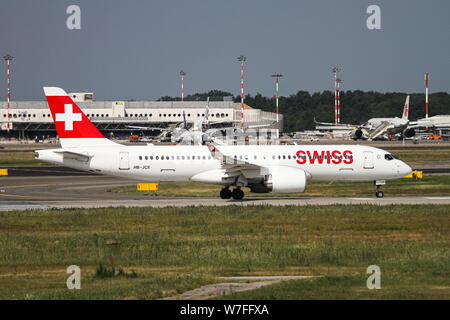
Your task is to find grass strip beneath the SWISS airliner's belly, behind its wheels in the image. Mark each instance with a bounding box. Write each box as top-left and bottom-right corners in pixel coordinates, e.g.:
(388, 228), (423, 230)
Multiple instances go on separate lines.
(108, 175), (450, 197)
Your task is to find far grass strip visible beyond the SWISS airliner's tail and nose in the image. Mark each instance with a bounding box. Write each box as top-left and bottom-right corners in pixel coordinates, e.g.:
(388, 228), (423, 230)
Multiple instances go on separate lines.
(0, 146), (450, 166)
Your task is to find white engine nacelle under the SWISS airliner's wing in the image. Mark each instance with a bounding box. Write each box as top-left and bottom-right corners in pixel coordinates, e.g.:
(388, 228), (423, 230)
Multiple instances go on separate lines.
(264, 166), (307, 193)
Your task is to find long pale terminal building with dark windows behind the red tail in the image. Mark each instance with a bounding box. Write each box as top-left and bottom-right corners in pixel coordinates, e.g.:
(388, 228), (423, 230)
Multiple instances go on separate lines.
(0, 93), (283, 138)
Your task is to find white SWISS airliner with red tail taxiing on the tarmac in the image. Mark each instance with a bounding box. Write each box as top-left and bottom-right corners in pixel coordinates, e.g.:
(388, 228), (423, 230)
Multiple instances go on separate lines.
(35, 87), (411, 199)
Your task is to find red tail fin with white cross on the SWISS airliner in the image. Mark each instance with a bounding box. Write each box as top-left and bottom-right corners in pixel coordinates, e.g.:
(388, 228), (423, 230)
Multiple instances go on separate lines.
(44, 87), (116, 148)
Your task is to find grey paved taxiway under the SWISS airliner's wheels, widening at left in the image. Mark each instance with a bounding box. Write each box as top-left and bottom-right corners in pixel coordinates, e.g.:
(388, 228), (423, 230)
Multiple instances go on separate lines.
(0, 168), (450, 211)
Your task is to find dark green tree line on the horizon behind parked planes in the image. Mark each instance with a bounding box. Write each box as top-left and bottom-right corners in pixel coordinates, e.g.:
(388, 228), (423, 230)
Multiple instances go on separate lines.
(159, 90), (450, 132)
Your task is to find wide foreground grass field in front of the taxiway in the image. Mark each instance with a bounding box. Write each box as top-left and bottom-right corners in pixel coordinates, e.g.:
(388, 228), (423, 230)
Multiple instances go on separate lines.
(0, 205), (450, 299)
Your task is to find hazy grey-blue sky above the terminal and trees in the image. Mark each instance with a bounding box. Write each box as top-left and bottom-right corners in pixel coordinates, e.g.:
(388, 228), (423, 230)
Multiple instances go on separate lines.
(0, 0), (450, 100)
